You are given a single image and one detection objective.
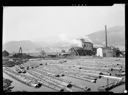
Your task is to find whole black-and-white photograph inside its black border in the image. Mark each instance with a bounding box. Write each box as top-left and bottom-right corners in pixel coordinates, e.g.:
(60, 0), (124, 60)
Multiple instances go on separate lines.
(2, 4), (127, 93)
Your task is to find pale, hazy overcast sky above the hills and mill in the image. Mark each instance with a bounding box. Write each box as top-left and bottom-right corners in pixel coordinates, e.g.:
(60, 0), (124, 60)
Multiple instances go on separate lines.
(3, 4), (125, 43)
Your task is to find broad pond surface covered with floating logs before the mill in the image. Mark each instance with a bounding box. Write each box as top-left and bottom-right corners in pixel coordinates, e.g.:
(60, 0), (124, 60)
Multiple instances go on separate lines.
(3, 57), (125, 93)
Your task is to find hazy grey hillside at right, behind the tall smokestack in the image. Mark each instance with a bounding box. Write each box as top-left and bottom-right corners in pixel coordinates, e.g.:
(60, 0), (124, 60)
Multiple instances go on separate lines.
(87, 26), (125, 49)
